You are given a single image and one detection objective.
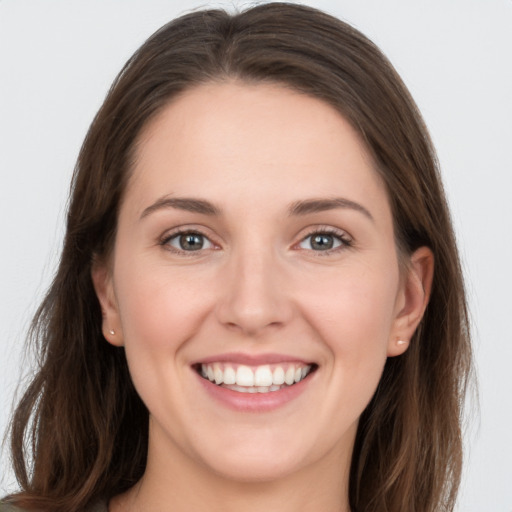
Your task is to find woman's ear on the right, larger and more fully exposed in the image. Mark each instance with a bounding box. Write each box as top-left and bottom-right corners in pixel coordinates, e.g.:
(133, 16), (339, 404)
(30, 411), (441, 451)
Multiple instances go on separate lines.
(387, 247), (434, 357)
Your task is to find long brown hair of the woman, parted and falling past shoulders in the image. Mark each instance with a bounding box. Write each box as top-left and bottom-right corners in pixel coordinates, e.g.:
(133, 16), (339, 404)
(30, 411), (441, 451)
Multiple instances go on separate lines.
(5, 3), (471, 512)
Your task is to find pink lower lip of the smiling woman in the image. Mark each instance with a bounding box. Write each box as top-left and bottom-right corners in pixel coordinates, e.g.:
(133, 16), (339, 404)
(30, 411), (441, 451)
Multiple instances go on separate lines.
(196, 372), (313, 412)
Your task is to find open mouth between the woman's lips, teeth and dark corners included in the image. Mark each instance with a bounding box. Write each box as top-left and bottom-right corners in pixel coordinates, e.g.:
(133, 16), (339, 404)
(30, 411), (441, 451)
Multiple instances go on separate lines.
(194, 362), (318, 393)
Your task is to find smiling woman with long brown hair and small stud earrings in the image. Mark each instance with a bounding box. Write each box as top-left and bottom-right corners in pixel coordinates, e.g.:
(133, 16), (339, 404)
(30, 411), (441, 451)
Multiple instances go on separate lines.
(4, 4), (470, 512)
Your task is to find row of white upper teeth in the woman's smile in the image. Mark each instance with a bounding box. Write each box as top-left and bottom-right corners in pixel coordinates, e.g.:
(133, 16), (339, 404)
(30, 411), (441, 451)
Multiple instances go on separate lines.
(201, 363), (311, 387)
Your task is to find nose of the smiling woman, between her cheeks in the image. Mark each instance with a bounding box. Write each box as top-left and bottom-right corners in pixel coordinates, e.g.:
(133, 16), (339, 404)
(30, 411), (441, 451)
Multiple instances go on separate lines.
(217, 243), (293, 337)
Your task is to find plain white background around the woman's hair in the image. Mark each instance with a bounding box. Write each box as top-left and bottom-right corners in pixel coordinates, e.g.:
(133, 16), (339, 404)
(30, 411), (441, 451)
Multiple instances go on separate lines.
(0, 0), (512, 512)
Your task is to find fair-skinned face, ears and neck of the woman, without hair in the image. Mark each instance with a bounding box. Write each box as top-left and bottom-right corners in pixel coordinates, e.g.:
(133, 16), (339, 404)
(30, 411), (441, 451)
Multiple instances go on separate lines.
(93, 82), (433, 512)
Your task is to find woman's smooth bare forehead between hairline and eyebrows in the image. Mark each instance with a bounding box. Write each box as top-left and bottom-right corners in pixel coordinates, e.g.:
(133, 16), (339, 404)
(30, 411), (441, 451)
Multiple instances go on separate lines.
(127, 82), (386, 217)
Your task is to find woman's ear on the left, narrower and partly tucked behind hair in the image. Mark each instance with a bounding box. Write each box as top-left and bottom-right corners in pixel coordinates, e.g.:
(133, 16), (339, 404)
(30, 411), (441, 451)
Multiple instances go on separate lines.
(91, 260), (124, 347)
